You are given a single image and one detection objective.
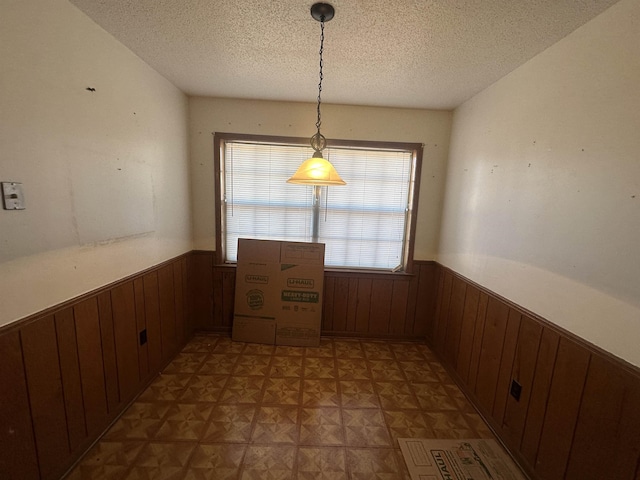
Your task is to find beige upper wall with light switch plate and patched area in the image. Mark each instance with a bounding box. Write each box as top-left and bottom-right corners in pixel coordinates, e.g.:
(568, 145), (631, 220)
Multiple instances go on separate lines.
(0, 0), (191, 325)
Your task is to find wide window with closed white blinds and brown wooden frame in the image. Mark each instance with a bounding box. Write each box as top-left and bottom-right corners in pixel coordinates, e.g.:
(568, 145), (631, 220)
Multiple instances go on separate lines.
(214, 133), (422, 271)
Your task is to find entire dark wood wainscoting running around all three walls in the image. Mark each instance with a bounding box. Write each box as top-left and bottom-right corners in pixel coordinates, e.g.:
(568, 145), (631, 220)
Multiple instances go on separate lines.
(0, 251), (640, 480)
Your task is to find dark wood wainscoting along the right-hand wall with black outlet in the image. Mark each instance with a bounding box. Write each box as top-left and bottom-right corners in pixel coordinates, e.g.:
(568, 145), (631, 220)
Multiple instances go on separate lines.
(427, 267), (640, 480)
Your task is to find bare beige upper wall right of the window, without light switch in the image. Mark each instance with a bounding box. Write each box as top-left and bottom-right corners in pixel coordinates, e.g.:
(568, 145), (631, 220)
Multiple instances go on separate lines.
(438, 0), (640, 365)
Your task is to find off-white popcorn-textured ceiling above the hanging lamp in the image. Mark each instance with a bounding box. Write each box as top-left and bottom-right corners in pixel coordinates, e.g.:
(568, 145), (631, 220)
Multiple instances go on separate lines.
(71, 0), (617, 109)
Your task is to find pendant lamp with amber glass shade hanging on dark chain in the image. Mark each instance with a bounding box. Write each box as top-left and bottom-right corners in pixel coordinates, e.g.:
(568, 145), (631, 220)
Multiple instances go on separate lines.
(287, 3), (346, 188)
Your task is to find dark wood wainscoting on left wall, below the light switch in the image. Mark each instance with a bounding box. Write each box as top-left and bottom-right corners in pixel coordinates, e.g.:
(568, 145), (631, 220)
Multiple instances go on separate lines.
(0, 255), (193, 480)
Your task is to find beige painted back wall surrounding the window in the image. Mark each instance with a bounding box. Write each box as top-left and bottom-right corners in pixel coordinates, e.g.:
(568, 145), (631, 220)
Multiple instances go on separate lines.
(189, 97), (451, 260)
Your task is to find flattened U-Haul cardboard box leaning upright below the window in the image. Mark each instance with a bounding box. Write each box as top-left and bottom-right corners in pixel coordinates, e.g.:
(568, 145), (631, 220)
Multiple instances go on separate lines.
(232, 238), (324, 346)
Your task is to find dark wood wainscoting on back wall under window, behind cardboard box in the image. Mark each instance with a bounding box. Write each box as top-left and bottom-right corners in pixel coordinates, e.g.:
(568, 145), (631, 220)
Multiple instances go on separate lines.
(190, 251), (438, 338)
